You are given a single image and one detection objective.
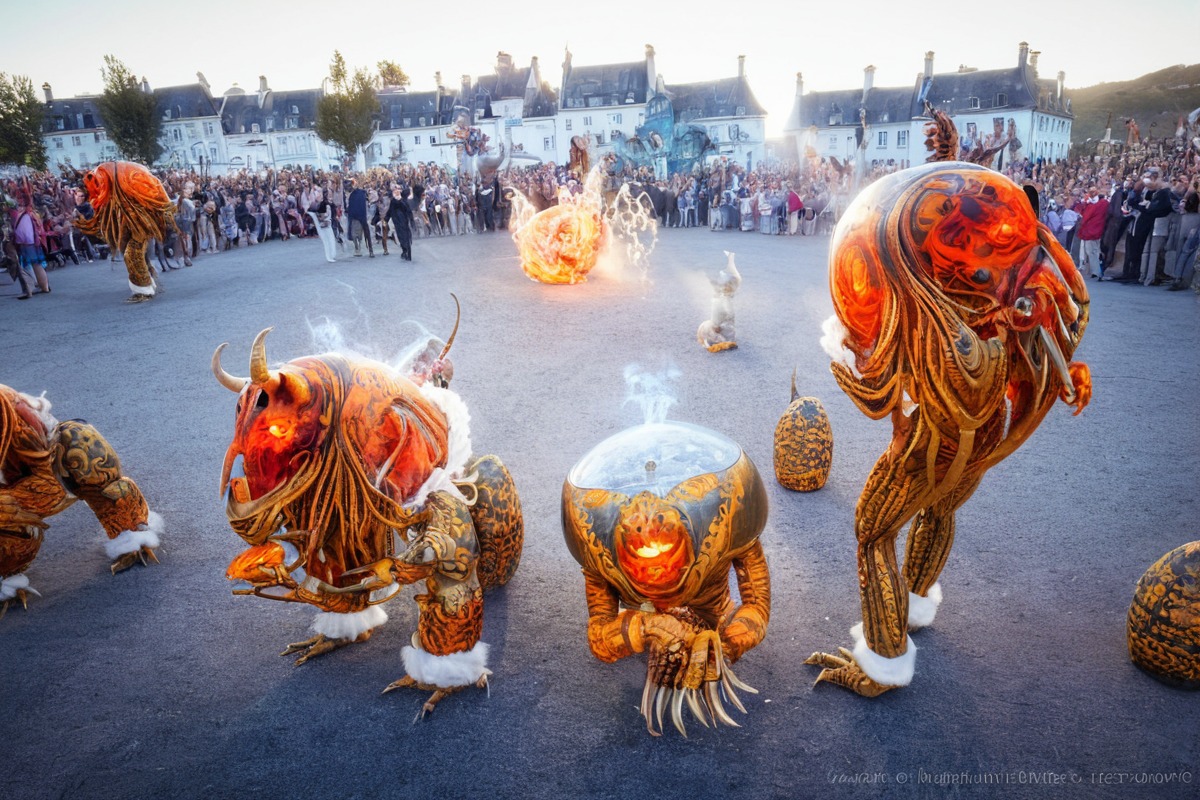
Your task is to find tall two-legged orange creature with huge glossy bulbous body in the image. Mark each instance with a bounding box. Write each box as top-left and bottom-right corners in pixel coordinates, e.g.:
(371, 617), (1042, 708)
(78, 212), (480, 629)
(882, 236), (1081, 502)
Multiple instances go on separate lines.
(808, 148), (1091, 697)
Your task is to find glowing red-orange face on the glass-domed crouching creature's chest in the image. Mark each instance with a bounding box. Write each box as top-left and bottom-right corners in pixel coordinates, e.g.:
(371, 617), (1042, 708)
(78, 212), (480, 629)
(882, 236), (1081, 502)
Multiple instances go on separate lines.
(613, 492), (692, 597)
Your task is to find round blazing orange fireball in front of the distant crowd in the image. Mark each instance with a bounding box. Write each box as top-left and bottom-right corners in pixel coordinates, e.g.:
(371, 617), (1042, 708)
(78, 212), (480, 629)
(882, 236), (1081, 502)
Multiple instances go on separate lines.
(512, 203), (605, 283)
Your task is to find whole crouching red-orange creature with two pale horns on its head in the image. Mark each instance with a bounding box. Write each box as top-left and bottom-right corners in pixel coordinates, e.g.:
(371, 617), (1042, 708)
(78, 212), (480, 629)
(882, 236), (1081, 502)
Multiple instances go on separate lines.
(212, 303), (523, 715)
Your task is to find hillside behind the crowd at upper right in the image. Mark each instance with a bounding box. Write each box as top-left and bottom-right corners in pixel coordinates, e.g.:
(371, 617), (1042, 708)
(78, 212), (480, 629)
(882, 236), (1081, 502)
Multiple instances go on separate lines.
(1067, 64), (1200, 143)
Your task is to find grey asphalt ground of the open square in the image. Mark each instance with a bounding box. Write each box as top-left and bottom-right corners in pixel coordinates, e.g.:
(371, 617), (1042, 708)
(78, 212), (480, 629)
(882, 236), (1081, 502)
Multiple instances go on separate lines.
(0, 229), (1200, 799)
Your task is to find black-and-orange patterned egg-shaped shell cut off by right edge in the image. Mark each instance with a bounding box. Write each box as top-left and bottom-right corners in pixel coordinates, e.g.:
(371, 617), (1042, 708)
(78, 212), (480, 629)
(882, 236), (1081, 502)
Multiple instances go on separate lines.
(1126, 541), (1200, 688)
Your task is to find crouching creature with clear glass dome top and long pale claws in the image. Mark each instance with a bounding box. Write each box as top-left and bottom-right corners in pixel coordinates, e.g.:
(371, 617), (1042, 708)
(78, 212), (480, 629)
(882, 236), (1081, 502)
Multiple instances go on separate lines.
(563, 422), (770, 735)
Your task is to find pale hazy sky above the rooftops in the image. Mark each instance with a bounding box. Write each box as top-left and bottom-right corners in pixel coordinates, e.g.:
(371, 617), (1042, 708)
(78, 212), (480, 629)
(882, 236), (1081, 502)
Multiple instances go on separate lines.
(0, 0), (1200, 134)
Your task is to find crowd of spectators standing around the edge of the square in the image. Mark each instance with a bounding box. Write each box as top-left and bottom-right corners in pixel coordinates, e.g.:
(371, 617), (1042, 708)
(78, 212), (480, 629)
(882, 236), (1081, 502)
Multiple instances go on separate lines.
(0, 130), (1200, 297)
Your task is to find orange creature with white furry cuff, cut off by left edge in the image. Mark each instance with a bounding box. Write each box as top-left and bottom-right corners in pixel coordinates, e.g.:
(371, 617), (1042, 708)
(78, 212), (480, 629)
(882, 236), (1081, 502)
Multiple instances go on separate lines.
(0, 385), (163, 616)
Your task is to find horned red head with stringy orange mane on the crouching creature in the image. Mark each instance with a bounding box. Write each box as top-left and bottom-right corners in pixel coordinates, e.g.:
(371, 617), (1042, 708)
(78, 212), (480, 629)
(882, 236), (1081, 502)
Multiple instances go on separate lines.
(212, 329), (450, 585)
